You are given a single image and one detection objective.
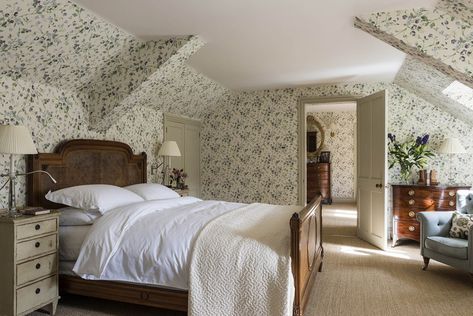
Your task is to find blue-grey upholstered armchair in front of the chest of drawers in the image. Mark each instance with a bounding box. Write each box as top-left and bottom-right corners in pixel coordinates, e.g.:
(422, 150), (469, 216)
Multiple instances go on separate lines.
(417, 191), (473, 276)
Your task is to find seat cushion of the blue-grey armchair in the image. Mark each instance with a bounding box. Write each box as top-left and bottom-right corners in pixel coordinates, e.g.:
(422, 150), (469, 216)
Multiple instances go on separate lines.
(425, 236), (468, 260)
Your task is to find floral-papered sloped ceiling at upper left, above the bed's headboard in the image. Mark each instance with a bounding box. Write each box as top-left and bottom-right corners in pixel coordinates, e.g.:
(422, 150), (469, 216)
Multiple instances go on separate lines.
(0, 0), (227, 130)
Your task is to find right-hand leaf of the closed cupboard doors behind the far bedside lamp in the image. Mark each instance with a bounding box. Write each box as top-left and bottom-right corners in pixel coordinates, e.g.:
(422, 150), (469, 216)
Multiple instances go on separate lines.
(184, 124), (201, 197)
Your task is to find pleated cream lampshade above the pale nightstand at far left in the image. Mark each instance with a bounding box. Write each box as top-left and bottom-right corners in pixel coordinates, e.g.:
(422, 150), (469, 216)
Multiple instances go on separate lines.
(0, 125), (38, 155)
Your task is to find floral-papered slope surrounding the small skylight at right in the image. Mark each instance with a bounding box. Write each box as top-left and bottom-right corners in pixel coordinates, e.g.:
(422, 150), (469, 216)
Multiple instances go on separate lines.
(394, 56), (473, 125)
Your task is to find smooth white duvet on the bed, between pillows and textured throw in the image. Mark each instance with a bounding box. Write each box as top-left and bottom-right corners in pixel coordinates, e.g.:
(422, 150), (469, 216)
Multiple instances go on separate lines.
(73, 197), (244, 289)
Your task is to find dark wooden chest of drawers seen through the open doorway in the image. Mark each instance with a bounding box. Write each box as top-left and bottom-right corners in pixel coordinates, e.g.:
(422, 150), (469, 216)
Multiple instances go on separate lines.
(307, 162), (332, 204)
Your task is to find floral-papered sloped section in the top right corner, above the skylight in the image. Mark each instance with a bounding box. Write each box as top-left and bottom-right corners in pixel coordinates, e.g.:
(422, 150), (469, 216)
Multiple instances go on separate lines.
(355, 0), (473, 88)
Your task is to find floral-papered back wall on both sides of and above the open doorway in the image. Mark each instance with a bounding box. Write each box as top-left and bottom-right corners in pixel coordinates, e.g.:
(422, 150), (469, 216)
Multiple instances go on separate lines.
(201, 83), (473, 204)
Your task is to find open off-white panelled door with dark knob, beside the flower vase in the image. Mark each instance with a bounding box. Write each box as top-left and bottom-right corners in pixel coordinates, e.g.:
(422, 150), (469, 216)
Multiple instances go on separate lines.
(356, 91), (387, 249)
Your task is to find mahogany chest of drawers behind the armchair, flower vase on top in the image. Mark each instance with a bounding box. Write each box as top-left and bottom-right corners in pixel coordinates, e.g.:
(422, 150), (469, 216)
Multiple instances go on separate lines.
(392, 185), (470, 247)
